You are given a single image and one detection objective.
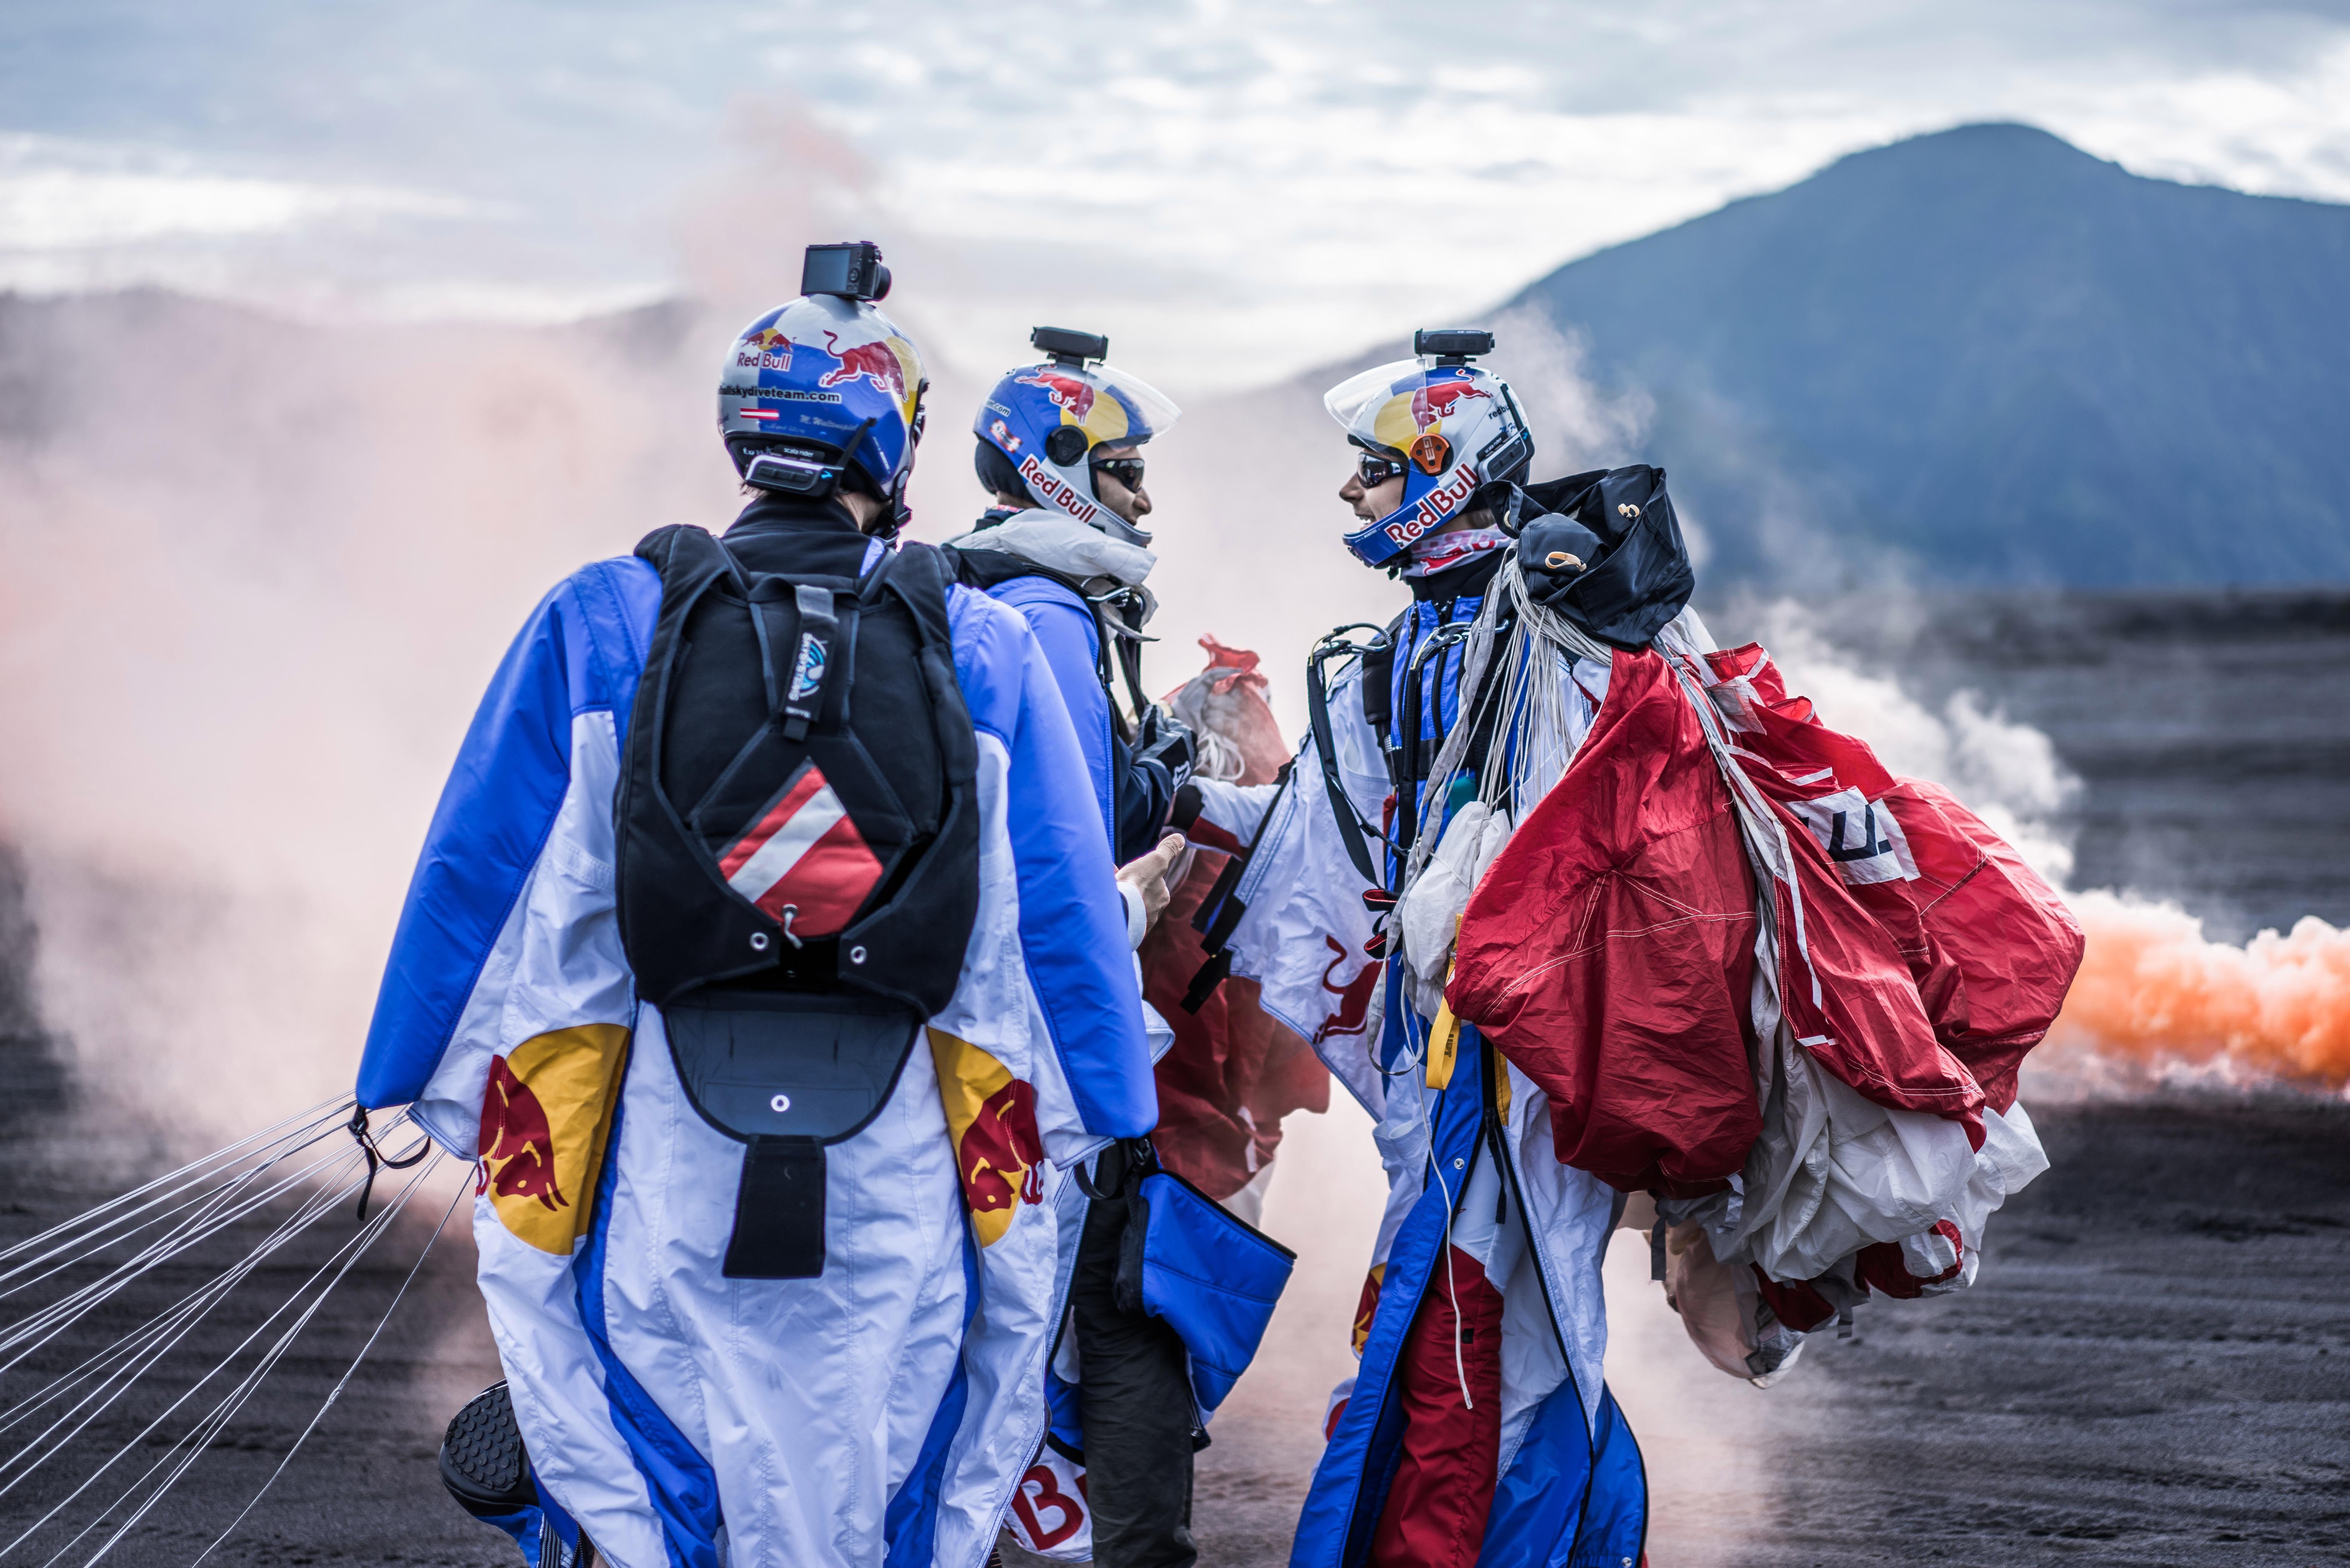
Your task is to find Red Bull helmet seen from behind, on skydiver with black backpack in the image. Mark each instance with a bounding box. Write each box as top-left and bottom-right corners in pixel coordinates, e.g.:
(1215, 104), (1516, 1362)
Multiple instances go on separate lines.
(719, 275), (930, 524)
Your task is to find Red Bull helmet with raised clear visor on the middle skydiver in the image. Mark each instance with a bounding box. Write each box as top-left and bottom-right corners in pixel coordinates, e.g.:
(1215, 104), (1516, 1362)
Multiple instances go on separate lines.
(970, 327), (1182, 545)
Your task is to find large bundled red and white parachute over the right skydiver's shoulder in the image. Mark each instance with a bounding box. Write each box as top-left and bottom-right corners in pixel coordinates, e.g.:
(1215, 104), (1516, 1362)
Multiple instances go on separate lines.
(1438, 562), (2082, 1359)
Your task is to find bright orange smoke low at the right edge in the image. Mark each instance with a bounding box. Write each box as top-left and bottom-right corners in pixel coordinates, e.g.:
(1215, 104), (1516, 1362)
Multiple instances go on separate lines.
(2049, 893), (2350, 1088)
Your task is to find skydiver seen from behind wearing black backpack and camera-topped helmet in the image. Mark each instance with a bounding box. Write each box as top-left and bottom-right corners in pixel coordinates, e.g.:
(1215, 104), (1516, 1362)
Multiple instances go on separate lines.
(357, 244), (1163, 1568)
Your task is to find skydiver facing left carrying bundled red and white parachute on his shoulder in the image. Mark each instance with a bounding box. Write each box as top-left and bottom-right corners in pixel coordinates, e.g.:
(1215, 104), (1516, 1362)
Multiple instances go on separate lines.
(1175, 329), (2082, 1568)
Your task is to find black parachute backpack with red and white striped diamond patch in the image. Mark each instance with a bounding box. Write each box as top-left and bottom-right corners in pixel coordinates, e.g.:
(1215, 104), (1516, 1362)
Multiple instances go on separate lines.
(616, 505), (980, 1279)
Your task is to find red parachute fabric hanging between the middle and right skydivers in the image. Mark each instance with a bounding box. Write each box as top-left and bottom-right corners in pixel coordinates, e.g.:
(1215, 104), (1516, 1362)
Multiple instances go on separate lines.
(1142, 637), (1330, 1218)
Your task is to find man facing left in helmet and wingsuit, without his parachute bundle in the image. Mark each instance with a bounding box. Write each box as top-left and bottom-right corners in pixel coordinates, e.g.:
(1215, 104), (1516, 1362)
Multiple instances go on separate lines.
(1191, 346), (1645, 1568)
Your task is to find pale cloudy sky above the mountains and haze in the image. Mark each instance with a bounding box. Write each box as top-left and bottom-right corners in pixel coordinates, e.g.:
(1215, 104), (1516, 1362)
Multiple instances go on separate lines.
(0, 0), (2350, 393)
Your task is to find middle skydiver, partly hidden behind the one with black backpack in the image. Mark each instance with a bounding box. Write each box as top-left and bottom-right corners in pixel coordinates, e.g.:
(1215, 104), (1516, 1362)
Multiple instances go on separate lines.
(947, 327), (1288, 1568)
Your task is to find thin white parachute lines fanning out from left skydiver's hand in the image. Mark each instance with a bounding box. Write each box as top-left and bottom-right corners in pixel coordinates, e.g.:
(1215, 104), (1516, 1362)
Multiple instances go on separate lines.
(0, 1100), (456, 1568)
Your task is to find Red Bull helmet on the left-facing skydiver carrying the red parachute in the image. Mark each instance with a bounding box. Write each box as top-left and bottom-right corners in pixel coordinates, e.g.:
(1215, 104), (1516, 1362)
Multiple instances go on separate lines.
(1323, 327), (1535, 566)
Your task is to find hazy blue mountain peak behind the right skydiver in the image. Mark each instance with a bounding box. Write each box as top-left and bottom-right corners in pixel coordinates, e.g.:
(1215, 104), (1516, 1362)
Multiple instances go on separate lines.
(1513, 125), (2350, 585)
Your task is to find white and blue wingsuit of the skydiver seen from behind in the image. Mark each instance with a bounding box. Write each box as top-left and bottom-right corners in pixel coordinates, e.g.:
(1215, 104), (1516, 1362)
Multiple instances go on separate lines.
(357, 540), (1156, 1568)
